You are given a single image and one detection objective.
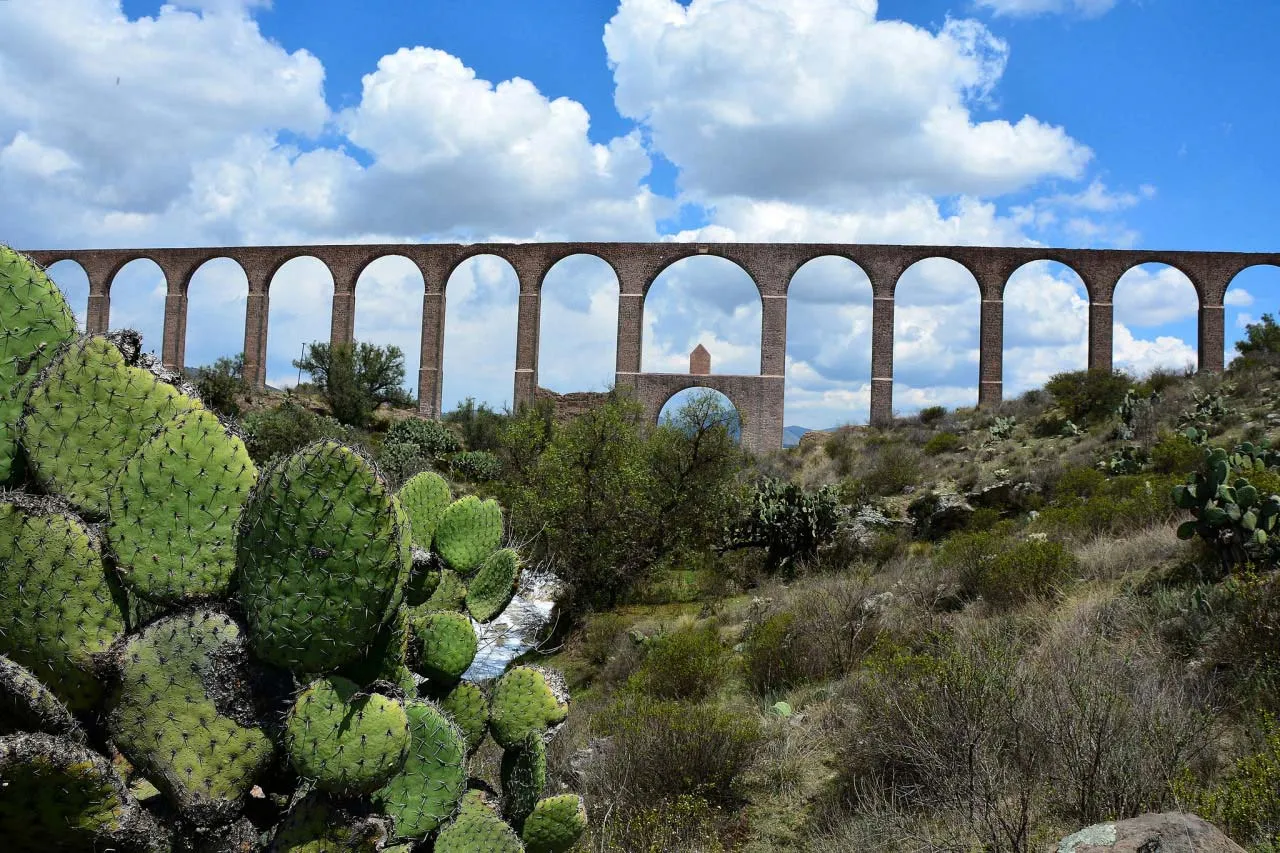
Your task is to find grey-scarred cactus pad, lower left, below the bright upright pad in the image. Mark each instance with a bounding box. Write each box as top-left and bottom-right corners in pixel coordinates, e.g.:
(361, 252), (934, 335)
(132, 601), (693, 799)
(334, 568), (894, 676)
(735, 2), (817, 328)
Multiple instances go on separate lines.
(108, 610), (274, 826)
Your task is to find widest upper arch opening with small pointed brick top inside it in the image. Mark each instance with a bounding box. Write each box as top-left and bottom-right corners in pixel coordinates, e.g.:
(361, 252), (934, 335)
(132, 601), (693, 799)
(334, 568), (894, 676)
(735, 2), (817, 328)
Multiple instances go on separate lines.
(641, 255), (763, 375)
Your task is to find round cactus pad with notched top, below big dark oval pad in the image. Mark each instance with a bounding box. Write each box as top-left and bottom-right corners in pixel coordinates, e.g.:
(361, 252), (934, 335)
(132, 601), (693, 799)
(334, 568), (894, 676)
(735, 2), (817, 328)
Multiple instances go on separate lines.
(284, 678), (410, 794)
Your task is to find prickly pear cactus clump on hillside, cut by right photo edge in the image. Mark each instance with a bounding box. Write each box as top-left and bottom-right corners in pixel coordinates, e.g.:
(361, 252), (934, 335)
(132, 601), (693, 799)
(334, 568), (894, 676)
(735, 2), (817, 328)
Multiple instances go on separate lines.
(1174, 444), (1280, 570)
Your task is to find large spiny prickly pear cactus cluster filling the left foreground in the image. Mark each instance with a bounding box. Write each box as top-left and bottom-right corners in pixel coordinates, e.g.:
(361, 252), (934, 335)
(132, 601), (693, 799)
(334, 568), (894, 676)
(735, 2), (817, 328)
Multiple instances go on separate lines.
(0, 247), (585, 853)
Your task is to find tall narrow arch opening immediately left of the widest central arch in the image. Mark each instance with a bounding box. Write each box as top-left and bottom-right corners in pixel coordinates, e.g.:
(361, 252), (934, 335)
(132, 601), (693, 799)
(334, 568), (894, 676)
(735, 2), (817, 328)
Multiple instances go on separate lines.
(538, 255), (618, 393)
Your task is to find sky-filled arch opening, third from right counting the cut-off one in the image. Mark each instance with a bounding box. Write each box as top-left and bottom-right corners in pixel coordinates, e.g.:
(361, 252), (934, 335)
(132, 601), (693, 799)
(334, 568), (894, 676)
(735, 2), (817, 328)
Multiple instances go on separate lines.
(1002, 261), (1089, 398)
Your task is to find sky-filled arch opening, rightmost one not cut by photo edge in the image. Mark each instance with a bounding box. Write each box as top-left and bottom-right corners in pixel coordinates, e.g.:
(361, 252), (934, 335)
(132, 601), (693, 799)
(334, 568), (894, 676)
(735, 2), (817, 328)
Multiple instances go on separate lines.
(1111, 263), (1199, 377)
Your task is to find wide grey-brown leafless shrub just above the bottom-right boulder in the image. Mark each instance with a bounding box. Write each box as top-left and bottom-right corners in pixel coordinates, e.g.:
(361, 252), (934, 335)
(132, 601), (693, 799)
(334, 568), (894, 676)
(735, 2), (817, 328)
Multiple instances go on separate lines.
(844, 619), (1210, 850)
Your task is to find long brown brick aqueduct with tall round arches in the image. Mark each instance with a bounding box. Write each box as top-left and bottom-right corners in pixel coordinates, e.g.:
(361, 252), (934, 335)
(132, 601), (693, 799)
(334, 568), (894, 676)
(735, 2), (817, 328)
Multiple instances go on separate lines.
(17, 243), (1280, 450)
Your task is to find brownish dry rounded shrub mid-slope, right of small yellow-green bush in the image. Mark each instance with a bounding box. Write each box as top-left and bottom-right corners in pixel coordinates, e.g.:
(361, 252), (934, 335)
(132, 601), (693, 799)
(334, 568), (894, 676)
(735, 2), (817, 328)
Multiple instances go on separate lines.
(742, 576), (878, 694)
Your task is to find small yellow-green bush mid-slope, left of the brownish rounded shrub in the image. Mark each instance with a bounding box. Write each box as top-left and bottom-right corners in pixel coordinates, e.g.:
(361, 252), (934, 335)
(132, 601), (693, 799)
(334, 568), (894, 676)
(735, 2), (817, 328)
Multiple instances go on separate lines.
(628, 625), (728, 701)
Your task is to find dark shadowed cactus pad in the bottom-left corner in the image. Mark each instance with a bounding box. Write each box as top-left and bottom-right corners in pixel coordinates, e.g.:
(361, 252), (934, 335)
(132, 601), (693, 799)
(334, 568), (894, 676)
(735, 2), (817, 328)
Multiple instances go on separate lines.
(0, 734), (168, 853)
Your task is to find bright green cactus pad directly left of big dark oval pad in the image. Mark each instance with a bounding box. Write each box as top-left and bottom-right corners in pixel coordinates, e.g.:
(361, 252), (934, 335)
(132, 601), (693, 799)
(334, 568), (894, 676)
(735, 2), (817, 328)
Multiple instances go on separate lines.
(106, 409), (257, 603)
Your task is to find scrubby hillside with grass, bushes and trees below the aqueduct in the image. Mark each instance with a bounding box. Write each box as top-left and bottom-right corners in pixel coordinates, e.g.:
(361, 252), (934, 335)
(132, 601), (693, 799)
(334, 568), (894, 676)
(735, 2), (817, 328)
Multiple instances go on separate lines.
(186, 318), (1280, 853)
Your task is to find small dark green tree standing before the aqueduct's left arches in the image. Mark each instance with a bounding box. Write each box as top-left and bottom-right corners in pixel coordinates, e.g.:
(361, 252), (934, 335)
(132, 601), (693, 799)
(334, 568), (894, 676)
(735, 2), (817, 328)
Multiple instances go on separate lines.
(293, 343), (412, 427)
